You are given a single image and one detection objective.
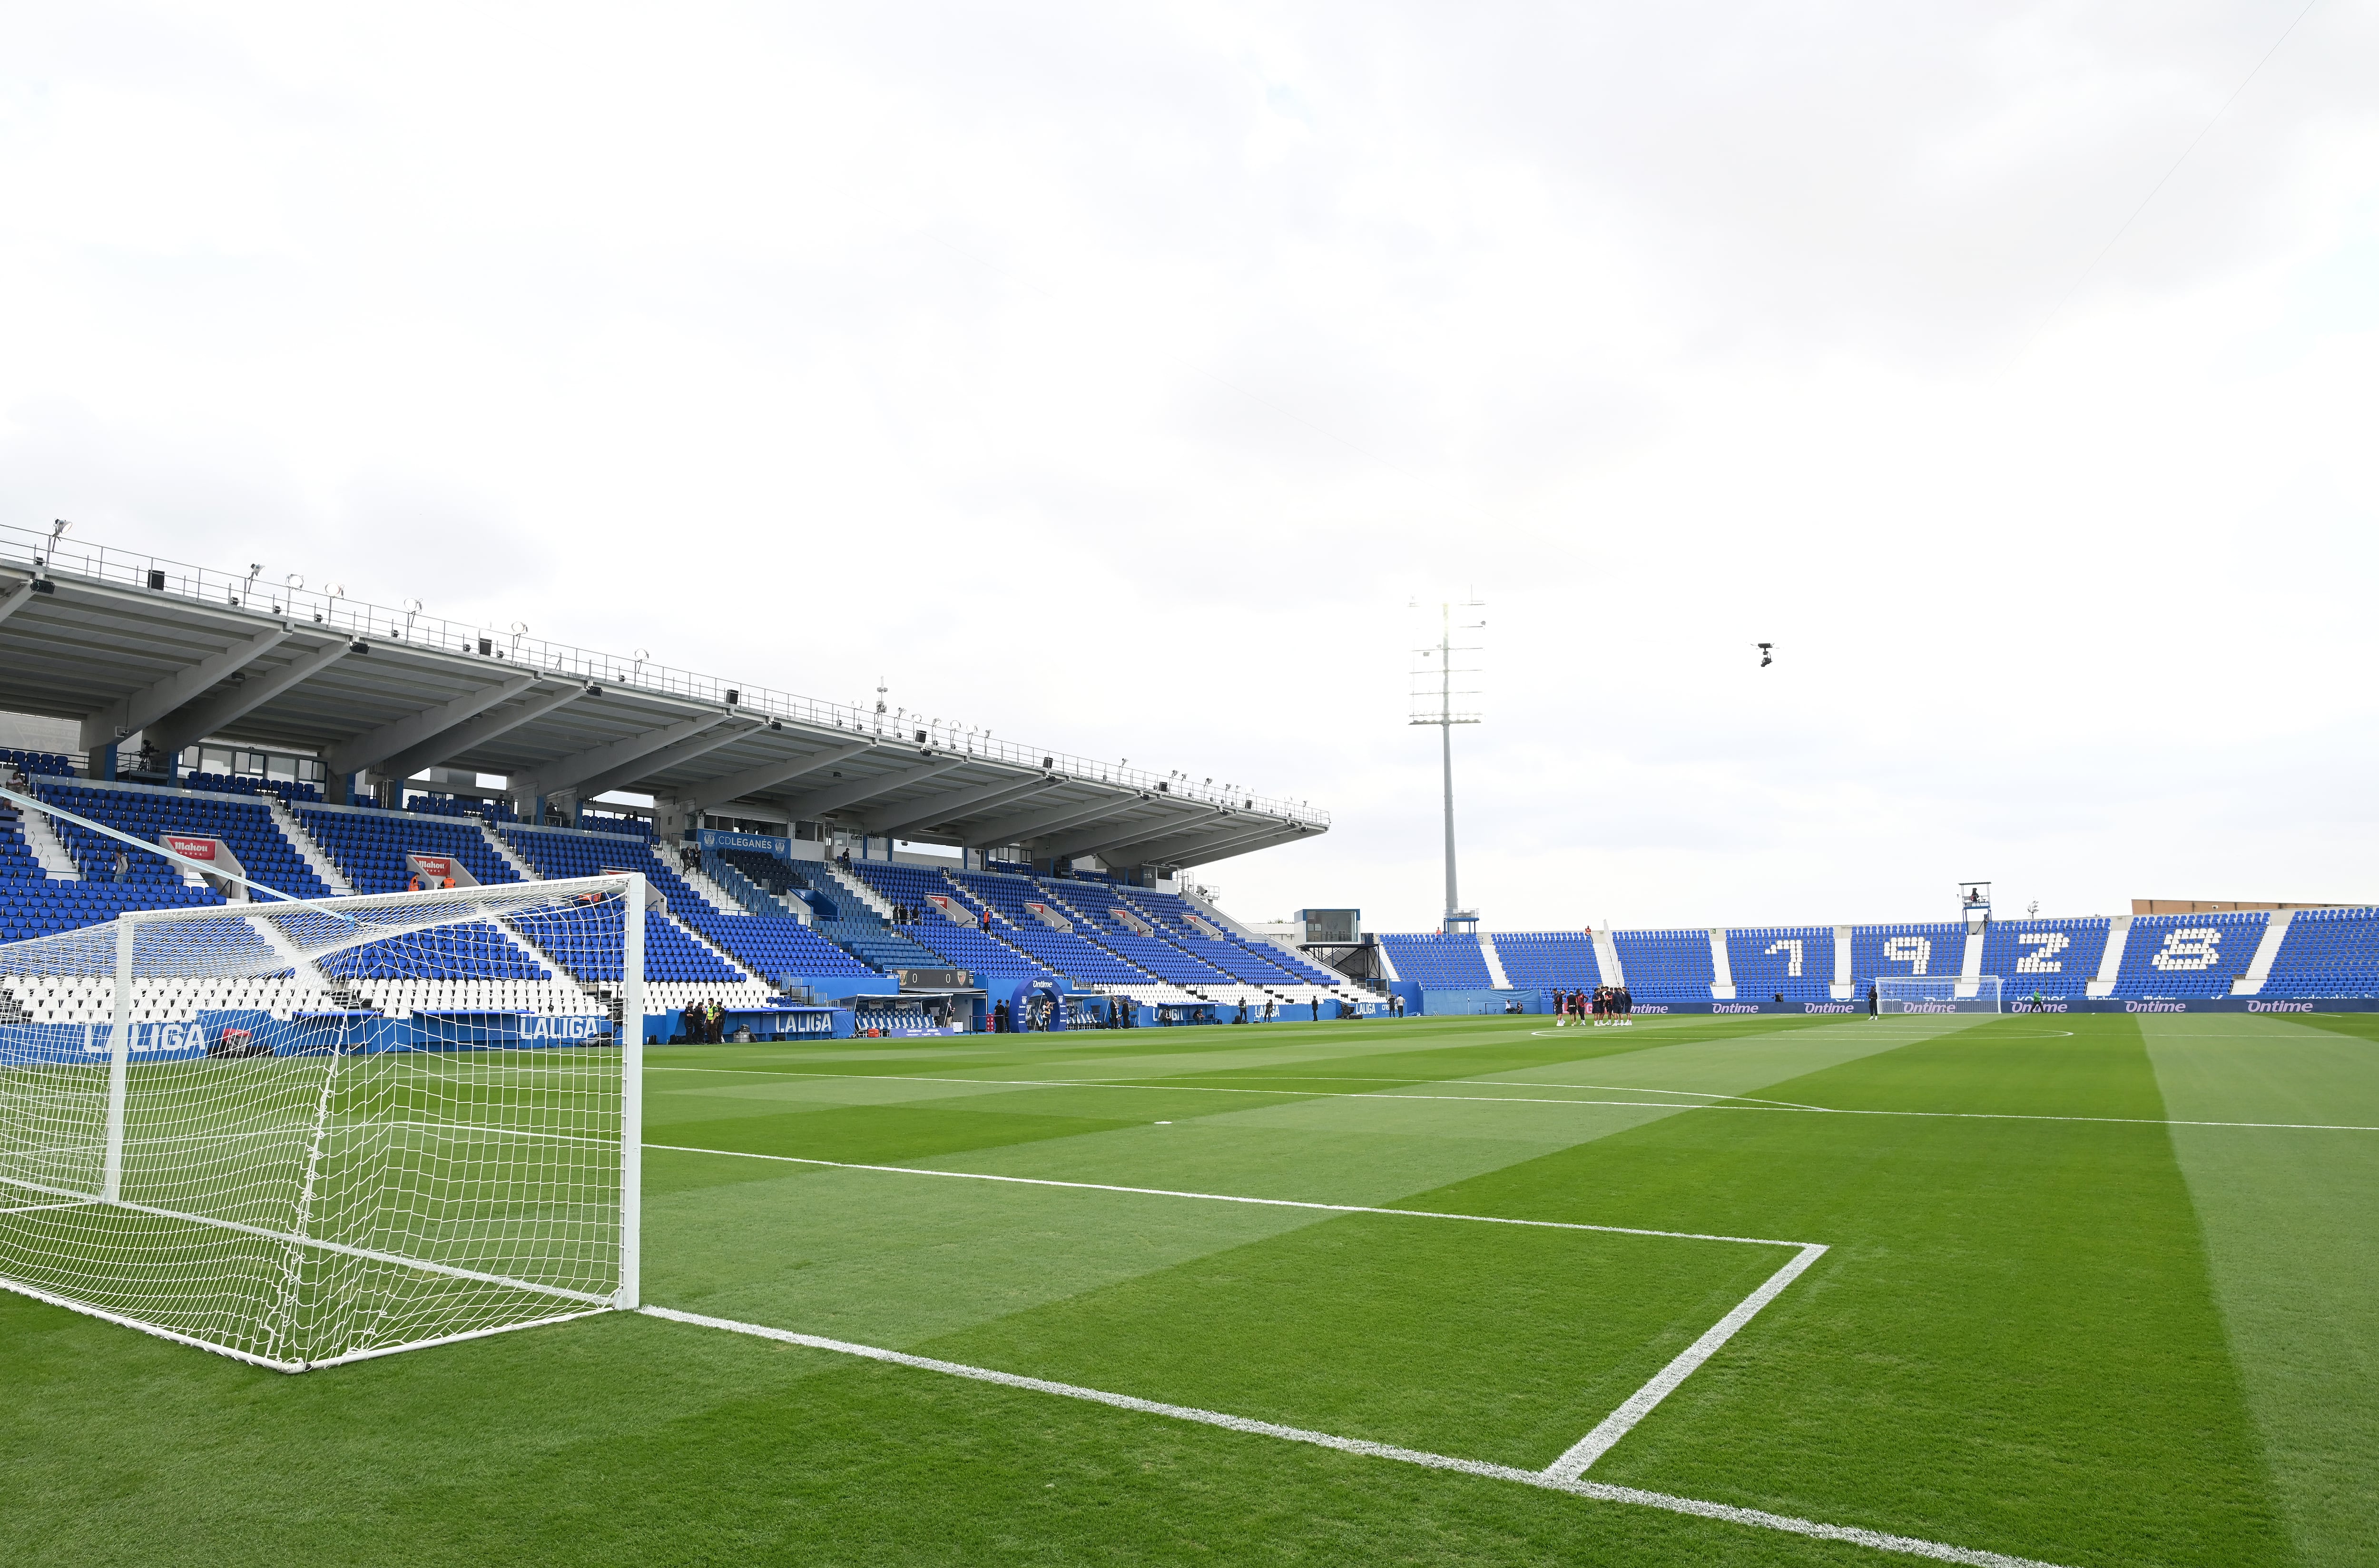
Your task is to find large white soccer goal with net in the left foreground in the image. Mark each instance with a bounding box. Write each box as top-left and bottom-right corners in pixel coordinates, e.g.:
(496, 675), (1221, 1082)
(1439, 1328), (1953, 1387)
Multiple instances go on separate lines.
(0, 876), (647, 1371)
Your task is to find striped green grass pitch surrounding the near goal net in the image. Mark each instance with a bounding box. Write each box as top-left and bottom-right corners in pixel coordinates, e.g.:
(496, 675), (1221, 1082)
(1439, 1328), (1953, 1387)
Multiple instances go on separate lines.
(0, 1016), (2379, 1568)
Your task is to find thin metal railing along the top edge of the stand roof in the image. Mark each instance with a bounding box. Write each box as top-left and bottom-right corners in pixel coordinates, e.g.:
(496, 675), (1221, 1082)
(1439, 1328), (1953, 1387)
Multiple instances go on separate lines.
(0, 523), (1330, 828)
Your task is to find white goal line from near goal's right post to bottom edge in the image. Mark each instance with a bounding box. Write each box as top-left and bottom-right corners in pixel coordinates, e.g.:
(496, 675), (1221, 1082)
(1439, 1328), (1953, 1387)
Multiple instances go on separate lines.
(638, 1303), (2055, 1568)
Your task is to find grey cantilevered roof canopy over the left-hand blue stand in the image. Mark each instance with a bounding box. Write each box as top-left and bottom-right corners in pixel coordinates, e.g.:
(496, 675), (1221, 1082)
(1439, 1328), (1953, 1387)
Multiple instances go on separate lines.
(0, 526), (1330, 866)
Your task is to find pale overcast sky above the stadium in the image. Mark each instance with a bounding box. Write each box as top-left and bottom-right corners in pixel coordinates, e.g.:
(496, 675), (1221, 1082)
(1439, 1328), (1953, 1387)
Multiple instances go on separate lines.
(0, 0), (2379, 931)
